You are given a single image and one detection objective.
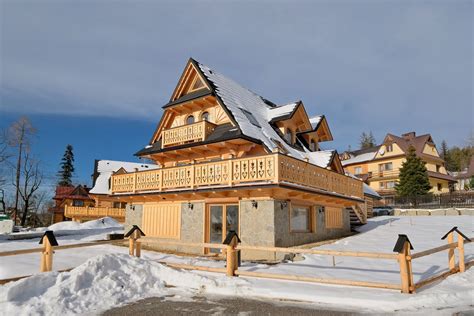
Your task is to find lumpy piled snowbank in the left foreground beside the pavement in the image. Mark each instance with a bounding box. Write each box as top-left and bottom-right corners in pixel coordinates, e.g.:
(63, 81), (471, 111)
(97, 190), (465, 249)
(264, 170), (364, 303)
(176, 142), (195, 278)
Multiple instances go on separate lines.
(0, 254), (248, 315)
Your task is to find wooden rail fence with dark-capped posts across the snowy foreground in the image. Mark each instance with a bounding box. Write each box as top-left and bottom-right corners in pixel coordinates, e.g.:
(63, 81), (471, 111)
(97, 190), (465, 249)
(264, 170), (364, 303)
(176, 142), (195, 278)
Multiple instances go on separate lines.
(0, 226), (474, 293)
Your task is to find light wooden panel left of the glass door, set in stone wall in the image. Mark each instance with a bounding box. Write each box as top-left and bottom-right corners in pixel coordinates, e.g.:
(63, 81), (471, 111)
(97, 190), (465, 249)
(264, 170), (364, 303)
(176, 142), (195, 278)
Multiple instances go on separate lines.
(142, 203), (181, 239)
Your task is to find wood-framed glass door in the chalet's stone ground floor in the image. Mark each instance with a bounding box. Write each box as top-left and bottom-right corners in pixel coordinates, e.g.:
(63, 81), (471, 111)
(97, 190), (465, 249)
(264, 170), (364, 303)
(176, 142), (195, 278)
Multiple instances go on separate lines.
(206, 204), (239, 253)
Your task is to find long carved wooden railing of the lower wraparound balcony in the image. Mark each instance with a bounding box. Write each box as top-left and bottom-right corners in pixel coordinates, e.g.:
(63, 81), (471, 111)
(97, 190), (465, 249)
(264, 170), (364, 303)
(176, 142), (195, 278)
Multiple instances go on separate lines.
(111, 153), (363, 198)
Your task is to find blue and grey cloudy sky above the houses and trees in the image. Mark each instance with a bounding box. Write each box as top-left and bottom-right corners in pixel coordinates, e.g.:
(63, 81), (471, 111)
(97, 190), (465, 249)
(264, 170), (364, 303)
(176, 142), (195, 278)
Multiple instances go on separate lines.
(0, 0), (474, 188)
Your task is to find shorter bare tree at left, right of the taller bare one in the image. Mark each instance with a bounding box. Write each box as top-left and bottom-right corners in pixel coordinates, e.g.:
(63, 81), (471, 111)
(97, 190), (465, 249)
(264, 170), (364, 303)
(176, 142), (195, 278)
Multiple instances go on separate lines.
(13, 152), (43, 226)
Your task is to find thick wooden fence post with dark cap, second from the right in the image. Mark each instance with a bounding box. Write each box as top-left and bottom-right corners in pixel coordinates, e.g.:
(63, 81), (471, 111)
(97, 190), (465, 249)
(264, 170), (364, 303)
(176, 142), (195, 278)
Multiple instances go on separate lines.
(393, 234), (415, 293)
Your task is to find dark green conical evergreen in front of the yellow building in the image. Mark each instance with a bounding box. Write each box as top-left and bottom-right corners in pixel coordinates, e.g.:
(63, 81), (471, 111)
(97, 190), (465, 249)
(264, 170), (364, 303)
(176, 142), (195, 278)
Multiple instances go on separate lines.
(395, 146), (431, 205)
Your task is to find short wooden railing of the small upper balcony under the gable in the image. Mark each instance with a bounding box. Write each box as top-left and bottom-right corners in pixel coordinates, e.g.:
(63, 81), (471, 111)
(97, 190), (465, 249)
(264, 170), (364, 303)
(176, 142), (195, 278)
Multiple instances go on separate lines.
(161, 121), (216, 148)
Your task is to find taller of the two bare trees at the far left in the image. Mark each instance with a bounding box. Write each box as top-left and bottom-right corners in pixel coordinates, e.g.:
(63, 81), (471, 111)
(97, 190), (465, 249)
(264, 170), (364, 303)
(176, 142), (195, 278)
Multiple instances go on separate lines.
(8, 116), (36, 223)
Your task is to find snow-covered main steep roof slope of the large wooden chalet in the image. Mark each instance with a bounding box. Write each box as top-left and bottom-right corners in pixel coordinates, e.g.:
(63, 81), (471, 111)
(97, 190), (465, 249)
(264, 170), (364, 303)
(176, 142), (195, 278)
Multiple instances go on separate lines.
(197, 63), (332, 168)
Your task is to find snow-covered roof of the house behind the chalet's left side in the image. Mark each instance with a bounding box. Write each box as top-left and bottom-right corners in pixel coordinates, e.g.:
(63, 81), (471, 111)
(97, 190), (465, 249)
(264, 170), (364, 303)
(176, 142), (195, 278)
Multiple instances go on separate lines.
(89, 160), (158, 194)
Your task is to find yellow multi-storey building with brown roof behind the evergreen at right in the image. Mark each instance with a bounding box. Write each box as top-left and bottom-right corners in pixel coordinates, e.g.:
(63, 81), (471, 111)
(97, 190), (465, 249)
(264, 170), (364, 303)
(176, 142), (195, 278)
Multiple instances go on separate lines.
(341, 132), (455, 197)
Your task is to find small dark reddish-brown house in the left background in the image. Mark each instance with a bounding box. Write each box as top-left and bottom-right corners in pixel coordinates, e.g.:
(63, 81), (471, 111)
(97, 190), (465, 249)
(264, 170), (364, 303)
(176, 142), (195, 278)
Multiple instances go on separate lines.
(49, 185), (94, 223)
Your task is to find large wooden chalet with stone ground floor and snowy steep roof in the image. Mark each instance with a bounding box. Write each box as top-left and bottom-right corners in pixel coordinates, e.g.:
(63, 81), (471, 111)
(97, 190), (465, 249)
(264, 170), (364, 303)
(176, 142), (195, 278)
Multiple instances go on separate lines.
(110, 59), (365, 259)
